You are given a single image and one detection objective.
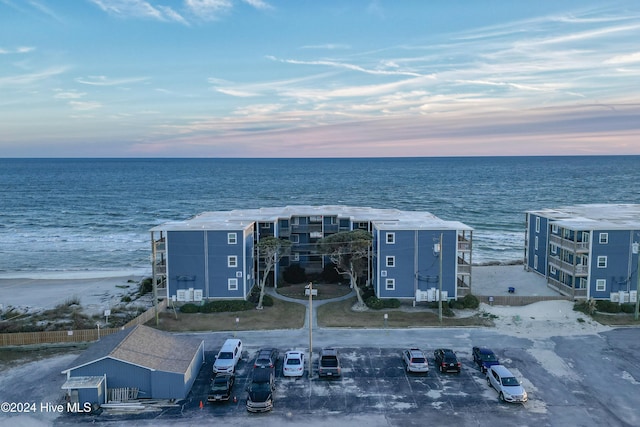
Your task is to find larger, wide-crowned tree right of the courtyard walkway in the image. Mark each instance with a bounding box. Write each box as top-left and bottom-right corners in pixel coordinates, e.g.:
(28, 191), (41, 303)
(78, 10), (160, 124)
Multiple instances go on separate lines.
(318, 230), (373, 306)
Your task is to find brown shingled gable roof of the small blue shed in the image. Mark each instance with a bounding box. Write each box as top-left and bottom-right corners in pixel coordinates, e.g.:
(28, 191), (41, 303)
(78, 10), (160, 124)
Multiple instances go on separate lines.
(62, 325), (202, 373)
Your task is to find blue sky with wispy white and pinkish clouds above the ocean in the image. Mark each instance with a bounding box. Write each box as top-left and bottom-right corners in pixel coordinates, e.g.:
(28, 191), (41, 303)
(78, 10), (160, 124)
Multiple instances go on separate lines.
(0, 0), (640, 157)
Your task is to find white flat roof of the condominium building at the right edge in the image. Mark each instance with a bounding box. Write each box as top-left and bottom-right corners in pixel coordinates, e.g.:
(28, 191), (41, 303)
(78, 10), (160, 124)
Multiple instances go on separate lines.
(527, 204), (640, 230)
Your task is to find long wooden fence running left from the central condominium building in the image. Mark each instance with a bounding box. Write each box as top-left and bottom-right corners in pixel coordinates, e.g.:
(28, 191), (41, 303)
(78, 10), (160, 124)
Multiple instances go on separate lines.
(0, 299), (167, 347)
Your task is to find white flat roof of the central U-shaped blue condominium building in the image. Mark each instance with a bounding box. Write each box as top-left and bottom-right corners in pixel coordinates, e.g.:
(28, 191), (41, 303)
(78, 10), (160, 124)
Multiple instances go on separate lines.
(151, 205), (473, 231)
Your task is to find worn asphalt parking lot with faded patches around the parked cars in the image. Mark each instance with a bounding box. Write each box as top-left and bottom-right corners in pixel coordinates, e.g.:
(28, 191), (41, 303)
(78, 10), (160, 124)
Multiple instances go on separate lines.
(46, 328), (640, 427)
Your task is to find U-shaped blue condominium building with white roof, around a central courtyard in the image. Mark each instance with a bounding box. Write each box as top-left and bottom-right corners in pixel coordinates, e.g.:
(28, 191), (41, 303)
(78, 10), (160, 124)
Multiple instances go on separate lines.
(151, 206), (473, 301)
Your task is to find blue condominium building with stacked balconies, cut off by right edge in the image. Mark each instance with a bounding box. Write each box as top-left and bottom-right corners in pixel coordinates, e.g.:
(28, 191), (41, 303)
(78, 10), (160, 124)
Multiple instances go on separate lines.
(525, 204), (640, 302)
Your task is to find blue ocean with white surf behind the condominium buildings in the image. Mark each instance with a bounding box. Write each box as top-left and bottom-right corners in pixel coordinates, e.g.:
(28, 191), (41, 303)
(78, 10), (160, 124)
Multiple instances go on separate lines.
(0, 156), (640, 278)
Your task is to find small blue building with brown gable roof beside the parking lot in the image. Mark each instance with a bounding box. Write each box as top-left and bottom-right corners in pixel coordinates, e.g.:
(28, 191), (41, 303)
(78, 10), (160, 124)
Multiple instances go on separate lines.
(62, 325), (204, 405)
